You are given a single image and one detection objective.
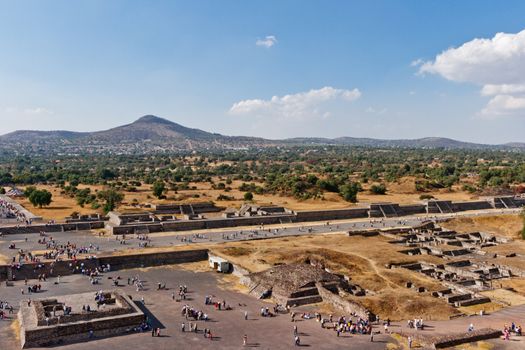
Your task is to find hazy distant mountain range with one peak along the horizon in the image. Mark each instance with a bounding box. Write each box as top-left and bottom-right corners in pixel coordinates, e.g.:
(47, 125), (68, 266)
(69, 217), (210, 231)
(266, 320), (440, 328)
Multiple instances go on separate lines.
(0, 115), (525, 153)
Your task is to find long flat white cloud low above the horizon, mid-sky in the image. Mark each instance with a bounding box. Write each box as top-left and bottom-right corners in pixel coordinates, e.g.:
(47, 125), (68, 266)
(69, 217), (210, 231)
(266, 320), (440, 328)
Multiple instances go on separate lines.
(229, 86), (361, 119)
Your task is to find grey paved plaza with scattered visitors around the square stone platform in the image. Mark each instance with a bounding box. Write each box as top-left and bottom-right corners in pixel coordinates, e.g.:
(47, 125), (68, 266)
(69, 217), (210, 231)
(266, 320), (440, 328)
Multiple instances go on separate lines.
(0, 266), (392, 350)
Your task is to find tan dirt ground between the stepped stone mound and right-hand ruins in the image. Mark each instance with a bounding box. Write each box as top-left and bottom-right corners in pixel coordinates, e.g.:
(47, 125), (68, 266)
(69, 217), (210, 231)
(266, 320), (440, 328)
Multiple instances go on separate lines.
(211, 234), (458, 320)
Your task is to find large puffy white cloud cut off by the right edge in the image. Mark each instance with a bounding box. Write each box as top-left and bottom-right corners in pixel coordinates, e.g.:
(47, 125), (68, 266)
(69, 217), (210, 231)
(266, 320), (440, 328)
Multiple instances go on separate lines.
(419, 30), (525, 116)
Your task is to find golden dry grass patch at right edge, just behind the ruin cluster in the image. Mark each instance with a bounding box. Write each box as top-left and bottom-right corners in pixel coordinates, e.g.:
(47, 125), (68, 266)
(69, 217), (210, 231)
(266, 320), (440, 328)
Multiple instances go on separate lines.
(442, 214), (523, 238)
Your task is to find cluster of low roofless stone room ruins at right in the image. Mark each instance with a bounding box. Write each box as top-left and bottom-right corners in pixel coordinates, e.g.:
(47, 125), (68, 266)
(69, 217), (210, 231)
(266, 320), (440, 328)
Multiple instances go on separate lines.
(379, 222), (522, 307)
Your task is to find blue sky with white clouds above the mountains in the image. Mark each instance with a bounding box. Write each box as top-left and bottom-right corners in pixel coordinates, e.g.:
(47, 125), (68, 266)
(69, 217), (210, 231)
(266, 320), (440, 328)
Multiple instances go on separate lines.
(0, 0), (525, 143)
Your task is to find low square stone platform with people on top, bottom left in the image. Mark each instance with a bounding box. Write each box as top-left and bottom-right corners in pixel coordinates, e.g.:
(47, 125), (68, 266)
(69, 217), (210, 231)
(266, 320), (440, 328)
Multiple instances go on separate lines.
(18, 291), (145, 348)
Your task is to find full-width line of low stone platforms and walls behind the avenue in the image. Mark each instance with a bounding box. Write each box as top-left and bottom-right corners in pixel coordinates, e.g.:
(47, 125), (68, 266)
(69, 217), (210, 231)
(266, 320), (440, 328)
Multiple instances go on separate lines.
(0, 197), (525, 234)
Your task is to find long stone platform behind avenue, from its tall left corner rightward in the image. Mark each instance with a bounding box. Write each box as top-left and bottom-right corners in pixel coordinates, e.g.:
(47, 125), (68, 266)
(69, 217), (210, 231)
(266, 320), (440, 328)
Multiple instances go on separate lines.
(100, 198), (525, 234)
